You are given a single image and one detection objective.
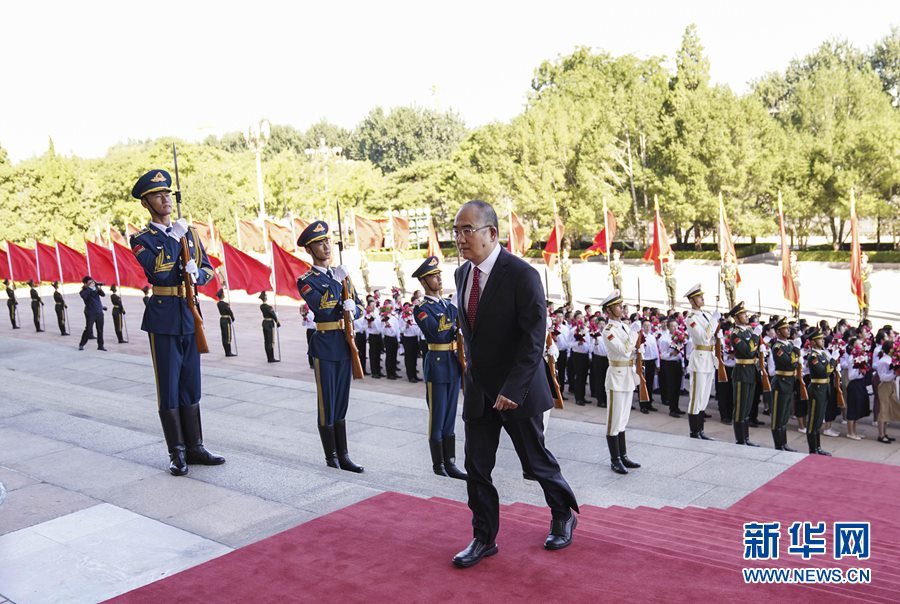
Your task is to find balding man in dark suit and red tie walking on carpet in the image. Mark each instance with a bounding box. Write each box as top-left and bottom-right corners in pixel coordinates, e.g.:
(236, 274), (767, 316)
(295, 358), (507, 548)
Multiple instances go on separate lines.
(453, 201), (578, 568)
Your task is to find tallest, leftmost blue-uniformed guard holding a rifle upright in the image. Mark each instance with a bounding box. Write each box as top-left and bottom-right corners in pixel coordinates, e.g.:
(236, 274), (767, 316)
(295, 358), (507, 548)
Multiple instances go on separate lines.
(131, 170), (225, 476)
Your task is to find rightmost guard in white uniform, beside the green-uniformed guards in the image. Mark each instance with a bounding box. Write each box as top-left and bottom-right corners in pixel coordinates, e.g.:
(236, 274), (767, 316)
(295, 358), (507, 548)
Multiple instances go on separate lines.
(684, 283), (719, 440)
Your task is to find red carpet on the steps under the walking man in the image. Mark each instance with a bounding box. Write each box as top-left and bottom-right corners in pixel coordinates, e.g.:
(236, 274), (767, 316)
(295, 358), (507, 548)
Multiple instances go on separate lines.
(114, 456), (900, 604)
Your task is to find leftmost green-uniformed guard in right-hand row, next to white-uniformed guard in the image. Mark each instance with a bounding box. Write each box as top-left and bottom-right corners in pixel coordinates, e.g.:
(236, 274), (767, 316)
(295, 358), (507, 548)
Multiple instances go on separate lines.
(729, 302), (759, 447)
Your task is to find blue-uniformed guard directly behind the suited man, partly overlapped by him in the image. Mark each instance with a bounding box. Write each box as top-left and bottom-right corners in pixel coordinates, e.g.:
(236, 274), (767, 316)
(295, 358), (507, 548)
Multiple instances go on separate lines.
(410, 256), (466, 480)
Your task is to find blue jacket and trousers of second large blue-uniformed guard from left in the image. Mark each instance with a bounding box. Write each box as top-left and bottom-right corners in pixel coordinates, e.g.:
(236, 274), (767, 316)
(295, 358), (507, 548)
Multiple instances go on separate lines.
(297, 268), (362, 428)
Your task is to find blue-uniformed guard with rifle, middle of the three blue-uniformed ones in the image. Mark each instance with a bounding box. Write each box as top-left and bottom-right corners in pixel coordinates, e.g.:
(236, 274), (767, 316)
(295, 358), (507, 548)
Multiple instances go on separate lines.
(297, 220), (363, 472)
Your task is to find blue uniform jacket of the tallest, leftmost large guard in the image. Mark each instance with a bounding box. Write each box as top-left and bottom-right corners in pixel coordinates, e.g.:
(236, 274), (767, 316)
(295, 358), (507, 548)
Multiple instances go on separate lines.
(131, 225), (213, 335)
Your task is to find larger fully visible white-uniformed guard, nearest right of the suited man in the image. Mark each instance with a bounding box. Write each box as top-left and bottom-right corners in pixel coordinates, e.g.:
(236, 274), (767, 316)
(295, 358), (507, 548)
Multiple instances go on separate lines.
(602, 290), (641, 474)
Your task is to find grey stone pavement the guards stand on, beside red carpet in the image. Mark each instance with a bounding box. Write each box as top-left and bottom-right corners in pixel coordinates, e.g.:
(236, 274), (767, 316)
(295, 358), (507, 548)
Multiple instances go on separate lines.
(0, 286), (900, 604)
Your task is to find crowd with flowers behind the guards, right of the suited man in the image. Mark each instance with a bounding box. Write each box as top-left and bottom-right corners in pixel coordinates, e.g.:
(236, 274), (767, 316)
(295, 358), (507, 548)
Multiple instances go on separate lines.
(548, 301), (900, 452)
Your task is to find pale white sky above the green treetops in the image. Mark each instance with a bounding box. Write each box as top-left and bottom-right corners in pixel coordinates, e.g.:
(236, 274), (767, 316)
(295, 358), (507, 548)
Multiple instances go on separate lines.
(0, 0), (900, 162)
